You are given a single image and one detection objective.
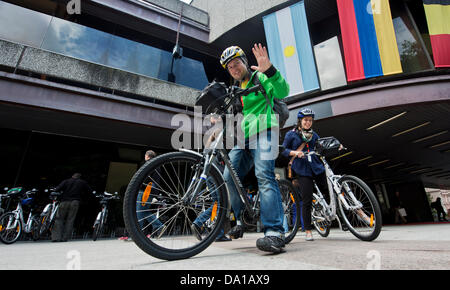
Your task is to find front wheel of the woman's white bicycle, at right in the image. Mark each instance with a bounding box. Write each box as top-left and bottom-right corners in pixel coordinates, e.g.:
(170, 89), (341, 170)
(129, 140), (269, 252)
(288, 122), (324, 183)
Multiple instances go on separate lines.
(338, 175), (382, 241)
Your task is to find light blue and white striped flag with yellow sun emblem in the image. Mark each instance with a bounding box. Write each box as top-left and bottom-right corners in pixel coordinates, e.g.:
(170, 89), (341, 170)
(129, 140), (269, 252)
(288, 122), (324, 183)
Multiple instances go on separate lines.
(263, 1), (319, 95)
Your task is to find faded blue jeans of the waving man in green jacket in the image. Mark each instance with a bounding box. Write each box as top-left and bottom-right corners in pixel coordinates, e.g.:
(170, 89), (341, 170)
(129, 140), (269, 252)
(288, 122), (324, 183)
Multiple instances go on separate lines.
(224, 131), (285, 237)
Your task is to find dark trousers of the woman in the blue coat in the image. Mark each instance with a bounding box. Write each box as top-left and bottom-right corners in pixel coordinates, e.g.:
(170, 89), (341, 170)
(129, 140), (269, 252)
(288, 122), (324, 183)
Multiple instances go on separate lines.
(296, 173), (329, 231)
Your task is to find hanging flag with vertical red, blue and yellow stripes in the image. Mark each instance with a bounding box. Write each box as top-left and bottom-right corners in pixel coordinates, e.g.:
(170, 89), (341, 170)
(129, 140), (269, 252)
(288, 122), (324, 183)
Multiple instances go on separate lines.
(337, 0), (403, 81)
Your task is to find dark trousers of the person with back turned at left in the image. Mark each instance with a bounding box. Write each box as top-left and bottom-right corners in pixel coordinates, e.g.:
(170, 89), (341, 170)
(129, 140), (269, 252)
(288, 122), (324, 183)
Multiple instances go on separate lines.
(52, 200), (80, 241)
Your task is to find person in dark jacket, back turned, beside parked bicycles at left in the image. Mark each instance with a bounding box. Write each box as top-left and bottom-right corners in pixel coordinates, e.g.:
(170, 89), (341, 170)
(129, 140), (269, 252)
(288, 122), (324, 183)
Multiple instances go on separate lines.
(52, 173), (92, 242)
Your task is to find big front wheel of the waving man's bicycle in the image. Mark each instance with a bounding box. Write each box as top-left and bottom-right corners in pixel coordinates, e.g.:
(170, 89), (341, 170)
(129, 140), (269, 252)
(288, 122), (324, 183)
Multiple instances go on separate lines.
(123, 152), (228, 260)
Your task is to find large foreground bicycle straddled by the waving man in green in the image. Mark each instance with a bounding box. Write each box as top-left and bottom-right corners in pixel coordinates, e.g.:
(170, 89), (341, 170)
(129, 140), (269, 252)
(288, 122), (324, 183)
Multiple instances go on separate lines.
(123, 83), (300, 260)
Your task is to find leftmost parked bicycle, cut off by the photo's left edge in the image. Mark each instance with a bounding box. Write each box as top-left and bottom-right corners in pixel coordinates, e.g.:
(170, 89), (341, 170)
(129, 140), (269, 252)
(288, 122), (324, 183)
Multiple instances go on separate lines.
(0, 187), (39, 244)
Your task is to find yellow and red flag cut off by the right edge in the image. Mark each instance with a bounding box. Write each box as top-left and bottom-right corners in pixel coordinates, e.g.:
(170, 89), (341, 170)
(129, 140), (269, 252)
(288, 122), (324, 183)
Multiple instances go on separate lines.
(423, 0), (450, 67)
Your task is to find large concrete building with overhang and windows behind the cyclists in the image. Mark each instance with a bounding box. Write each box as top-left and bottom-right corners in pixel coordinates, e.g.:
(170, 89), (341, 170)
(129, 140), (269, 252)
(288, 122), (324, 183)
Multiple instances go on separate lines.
(0, 0), (450, 234)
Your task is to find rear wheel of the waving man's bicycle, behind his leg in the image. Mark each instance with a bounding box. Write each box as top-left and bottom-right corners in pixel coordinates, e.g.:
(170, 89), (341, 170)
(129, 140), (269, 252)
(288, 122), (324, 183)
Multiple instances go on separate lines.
(278, 179), (301, 244)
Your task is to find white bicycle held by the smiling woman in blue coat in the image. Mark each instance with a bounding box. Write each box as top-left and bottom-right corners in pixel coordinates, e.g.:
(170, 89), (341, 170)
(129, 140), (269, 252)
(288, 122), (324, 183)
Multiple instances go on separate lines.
(305, 137), (382, 241)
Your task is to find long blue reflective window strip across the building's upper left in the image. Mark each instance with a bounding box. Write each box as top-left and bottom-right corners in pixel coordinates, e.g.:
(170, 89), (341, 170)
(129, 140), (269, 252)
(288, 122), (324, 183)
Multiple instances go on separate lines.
(0, 1), (208, 90)
